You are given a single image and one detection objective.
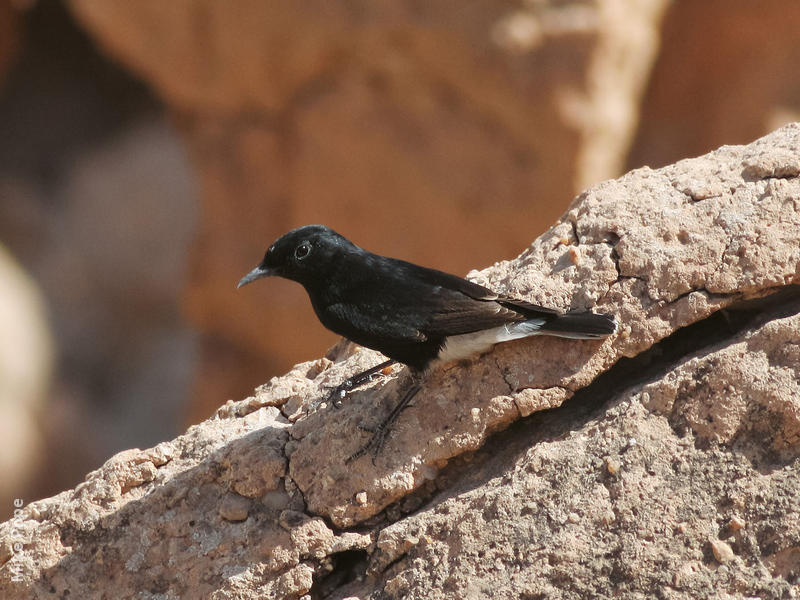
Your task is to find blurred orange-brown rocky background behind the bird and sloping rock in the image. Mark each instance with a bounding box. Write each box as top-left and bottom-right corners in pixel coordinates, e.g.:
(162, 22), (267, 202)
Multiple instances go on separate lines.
(0, 0), (800, 518)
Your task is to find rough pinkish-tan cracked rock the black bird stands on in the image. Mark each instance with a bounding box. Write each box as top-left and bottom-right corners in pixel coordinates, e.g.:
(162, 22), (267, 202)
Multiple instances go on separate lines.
(0, 124), (800, 599)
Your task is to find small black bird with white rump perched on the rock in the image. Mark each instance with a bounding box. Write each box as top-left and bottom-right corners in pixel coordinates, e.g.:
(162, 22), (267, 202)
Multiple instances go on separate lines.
(237, 225), (616, 460)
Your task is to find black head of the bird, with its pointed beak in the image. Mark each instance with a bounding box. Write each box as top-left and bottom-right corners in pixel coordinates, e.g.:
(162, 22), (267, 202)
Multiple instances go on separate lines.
(236, 225), (354, 288)
